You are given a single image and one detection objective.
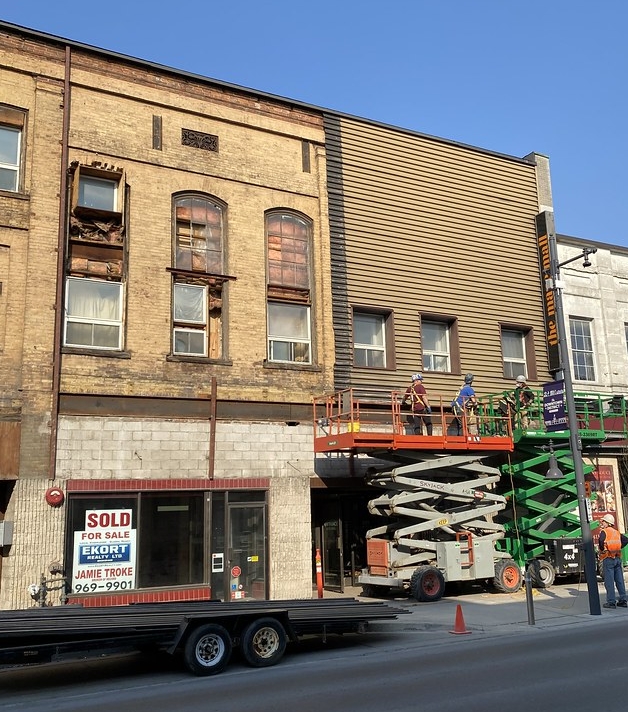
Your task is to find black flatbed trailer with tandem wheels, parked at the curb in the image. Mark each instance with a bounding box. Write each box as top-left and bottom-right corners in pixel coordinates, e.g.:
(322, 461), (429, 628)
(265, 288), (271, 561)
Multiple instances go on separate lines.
(0, 598), (408, 675)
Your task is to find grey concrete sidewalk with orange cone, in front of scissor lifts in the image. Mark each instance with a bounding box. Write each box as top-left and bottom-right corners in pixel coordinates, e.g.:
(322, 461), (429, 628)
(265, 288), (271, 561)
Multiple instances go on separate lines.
(324, 582), (628, 635)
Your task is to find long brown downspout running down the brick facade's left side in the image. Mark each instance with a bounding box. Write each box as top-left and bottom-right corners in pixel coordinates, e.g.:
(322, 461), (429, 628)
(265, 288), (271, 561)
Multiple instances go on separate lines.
(48, 45), (71, 480)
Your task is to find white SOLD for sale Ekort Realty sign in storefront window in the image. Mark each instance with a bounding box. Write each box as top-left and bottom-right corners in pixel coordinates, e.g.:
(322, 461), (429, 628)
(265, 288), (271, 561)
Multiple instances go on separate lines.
(72, 509), (137, 593)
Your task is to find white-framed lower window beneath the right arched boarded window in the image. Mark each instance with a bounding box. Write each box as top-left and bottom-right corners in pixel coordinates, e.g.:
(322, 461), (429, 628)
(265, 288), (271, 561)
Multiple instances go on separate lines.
(268, 302), (312, 363)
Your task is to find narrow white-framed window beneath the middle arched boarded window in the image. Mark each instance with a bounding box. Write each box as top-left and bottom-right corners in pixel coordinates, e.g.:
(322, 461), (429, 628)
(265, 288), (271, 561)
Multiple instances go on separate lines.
(173, 282), (207, 356)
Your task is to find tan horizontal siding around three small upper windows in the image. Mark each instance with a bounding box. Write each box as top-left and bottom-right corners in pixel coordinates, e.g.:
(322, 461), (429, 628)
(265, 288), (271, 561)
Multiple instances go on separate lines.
(327, 118), (549, 393)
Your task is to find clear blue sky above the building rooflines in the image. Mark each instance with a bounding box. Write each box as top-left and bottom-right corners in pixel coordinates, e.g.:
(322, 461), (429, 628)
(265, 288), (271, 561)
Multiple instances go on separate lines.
(0, 0), (628, 247)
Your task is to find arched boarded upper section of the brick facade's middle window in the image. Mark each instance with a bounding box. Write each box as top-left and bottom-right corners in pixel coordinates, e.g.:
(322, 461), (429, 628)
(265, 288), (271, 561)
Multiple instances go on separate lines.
(174, 196), (224, 274)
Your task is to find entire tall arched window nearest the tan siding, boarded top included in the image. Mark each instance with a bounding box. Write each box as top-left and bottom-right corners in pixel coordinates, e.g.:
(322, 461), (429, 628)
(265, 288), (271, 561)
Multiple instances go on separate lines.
(266, 211), (312, 364)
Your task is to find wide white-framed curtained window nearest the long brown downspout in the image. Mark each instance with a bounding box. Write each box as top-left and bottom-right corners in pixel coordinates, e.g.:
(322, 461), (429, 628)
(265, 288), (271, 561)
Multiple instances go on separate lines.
(64, 277), (123, 350)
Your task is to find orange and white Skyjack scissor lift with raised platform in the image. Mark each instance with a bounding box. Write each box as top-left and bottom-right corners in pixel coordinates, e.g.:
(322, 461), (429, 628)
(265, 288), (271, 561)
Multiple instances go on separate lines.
(314, 389), (522, 601)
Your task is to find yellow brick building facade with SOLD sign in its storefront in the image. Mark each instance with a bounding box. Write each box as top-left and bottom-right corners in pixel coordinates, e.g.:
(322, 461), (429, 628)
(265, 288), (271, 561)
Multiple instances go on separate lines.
(0, 25), (333, 608)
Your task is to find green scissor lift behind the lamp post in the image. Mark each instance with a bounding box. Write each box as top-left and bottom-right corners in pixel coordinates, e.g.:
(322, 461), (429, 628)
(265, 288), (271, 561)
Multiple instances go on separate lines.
(482, 391), (626, 587)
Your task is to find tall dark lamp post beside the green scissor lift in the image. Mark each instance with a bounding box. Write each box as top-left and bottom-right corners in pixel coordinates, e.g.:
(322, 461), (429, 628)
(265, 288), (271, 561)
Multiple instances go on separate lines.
(546, 212), (602, 616)
